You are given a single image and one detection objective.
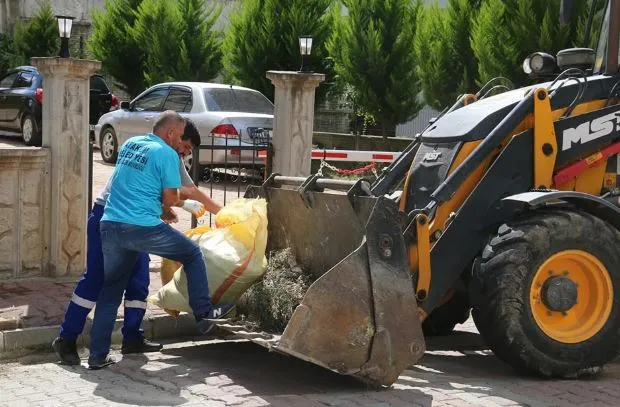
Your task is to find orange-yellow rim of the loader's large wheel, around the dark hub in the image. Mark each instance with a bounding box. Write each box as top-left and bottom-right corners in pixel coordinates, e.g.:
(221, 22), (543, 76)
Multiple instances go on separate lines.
(530, 250), (614, 343)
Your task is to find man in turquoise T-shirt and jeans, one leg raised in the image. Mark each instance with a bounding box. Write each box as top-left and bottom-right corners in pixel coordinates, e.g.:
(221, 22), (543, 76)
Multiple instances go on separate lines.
(88, 111), (234, 369)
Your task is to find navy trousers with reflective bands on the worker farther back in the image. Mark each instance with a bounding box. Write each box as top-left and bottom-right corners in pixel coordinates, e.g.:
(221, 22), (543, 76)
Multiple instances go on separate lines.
(60, 204), (149, 341)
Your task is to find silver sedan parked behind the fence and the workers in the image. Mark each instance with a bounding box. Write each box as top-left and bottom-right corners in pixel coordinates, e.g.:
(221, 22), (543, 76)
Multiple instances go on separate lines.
(95, 82), (274, 166)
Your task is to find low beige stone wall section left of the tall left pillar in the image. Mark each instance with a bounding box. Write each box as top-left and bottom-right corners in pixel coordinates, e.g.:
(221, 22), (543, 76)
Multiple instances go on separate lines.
(0, 148), (50, 281)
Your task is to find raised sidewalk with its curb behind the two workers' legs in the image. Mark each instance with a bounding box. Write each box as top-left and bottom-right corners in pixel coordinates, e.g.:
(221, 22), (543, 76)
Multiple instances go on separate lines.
(0, 256), (201, 359)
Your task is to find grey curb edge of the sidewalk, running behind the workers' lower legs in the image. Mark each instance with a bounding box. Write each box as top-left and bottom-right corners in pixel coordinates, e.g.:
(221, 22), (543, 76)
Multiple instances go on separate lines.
(0, 314), (198, 360)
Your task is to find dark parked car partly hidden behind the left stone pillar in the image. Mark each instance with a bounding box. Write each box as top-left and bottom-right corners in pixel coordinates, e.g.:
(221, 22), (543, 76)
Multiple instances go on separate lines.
(0, 66), (118, 146)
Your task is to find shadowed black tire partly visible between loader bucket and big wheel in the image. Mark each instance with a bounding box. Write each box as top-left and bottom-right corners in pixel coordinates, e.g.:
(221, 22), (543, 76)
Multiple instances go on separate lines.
(422, 291), (471, 336)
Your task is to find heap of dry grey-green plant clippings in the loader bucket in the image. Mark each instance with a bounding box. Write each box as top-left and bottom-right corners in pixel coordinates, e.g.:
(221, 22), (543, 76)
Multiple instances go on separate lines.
(237, 249), (314, 334)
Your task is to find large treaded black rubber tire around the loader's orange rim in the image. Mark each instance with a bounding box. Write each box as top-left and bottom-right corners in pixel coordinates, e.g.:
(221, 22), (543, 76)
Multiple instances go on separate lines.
(471, 209), (620, 377)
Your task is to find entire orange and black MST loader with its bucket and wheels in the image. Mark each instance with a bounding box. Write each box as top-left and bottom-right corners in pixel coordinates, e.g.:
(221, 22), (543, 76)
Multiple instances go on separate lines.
(208, 0), (620, 386)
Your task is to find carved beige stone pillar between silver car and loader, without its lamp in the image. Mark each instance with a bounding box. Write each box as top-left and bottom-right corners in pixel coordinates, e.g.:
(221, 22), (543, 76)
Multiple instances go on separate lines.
(267, 71), (325, 177)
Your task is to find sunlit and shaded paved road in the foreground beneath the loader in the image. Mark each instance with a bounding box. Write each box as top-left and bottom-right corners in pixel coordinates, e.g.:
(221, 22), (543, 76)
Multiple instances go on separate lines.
(0, 328), (620, 407)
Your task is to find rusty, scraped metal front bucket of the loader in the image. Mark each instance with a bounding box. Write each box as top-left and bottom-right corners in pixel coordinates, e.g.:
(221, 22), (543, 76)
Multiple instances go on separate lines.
(221, 177), (425, 386)
